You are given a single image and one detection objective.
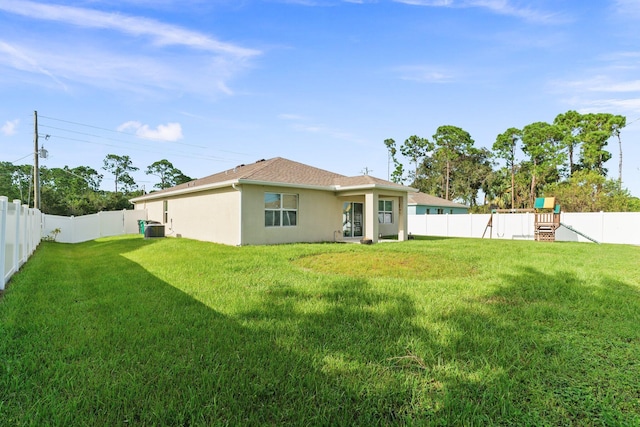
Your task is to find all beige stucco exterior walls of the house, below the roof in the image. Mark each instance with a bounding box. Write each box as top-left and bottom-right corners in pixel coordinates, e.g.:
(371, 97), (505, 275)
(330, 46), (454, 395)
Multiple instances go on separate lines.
(136, 183), (416, 246)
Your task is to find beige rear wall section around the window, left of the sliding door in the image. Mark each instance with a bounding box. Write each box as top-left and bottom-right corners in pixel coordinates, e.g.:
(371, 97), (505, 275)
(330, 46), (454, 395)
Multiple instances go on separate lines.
(240, 185), (342, 245)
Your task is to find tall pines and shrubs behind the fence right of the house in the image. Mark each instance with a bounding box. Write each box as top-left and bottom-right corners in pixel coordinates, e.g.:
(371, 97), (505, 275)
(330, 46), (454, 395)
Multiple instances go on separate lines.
(384, 111), (640, 212)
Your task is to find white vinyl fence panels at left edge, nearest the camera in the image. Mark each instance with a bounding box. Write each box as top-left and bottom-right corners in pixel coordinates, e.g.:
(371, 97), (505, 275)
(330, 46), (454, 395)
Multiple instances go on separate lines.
(0, 196), (42, 290)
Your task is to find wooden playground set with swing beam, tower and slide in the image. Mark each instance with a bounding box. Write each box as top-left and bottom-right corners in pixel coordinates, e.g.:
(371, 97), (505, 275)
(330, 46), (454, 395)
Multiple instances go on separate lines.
(482, 197), (599, 243)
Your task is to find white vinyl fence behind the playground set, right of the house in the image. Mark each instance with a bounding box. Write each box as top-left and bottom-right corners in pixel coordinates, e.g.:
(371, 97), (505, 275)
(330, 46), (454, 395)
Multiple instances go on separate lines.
(409, 212), (640, 245)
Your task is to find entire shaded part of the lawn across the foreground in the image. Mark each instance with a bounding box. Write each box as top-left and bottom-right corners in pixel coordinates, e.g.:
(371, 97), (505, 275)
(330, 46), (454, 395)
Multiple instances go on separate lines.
(0, 239), (640, 425)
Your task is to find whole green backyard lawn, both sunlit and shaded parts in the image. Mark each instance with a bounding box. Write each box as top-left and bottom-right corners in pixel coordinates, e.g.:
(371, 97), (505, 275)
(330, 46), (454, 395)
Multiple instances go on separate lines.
(0, 236), (640, 426)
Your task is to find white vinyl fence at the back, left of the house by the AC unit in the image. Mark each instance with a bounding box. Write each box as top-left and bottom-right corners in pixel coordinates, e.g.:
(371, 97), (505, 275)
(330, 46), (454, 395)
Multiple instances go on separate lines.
(42, 210), (147, 243)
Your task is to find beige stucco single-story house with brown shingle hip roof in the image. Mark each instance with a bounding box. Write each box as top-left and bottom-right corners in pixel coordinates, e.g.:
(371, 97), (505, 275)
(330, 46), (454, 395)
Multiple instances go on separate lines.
(131, 157), (417, 245)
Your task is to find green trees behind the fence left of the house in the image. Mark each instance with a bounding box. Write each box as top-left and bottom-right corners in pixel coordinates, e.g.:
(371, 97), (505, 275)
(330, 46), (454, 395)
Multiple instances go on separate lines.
(0, 154), (192, 216)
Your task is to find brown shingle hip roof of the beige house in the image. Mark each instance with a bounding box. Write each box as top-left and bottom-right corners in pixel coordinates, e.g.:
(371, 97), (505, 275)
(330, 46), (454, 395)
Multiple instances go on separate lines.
(132, 157), (415, 201)
